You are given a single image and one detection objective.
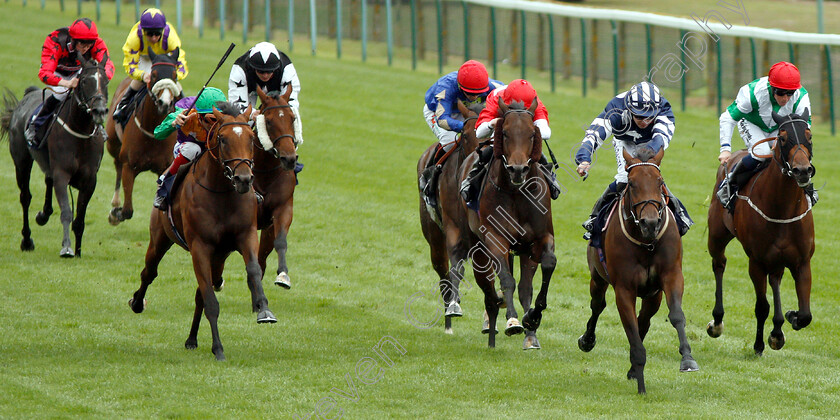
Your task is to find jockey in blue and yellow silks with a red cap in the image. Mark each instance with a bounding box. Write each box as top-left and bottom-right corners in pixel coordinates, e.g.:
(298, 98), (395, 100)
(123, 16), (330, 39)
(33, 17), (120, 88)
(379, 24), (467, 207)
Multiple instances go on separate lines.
(420, 60), (504, 207)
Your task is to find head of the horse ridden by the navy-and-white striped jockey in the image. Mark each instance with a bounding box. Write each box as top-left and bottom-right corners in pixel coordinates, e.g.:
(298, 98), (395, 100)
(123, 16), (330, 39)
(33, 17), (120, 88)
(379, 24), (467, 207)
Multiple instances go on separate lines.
(623, 147), (665, 242)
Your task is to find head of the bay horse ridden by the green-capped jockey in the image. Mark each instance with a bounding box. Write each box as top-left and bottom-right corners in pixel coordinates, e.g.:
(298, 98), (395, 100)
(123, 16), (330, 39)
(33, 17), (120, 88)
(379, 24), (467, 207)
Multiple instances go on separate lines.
(207, 102), (255, 194)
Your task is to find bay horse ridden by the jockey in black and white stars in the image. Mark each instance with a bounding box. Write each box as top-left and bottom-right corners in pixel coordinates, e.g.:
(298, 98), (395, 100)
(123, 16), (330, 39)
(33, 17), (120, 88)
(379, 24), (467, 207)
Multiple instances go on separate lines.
(254, 85), (297, 289)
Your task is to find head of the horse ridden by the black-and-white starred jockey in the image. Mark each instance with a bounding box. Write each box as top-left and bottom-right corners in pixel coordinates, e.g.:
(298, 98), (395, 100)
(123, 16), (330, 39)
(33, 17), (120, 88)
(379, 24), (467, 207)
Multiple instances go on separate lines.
(257, 84), (297, 170)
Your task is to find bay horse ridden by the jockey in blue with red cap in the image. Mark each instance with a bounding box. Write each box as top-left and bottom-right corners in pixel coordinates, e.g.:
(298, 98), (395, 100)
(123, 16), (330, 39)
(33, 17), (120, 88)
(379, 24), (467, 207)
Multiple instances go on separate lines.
(417, 101), (483, 334)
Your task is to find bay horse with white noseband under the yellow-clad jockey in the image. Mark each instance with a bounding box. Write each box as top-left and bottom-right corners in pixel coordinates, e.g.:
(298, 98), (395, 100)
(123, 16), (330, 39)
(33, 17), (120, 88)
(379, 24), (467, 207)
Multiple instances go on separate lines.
(105, 47), (182, 225)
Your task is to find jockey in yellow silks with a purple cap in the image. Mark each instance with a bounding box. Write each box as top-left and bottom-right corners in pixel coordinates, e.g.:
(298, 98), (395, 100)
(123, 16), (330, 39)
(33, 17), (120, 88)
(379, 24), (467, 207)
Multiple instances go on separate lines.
(114, 8), (189, 121)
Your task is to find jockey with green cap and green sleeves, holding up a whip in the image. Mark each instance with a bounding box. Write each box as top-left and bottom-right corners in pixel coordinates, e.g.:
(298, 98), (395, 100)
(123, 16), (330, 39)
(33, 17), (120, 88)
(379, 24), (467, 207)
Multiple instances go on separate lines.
(149, 87), (227, 211)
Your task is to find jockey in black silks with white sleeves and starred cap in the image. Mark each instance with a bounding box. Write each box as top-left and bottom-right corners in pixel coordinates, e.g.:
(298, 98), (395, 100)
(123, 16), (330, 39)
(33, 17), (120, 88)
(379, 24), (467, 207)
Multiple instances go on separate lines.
(228, 42), (303, 142)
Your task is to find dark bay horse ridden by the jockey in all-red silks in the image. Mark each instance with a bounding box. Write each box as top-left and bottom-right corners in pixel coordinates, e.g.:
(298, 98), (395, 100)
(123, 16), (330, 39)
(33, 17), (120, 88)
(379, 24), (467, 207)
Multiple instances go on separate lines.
(459, 97), (557, 350)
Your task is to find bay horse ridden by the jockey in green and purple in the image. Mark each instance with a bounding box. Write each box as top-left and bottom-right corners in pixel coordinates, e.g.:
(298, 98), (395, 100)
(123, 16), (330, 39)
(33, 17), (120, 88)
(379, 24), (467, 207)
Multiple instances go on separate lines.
(128, 103), (277, 360)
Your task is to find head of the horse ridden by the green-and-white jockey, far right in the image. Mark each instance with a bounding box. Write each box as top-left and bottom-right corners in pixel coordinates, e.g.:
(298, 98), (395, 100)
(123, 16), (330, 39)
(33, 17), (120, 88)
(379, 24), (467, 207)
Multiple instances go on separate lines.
(772, 108), (816, 187)
